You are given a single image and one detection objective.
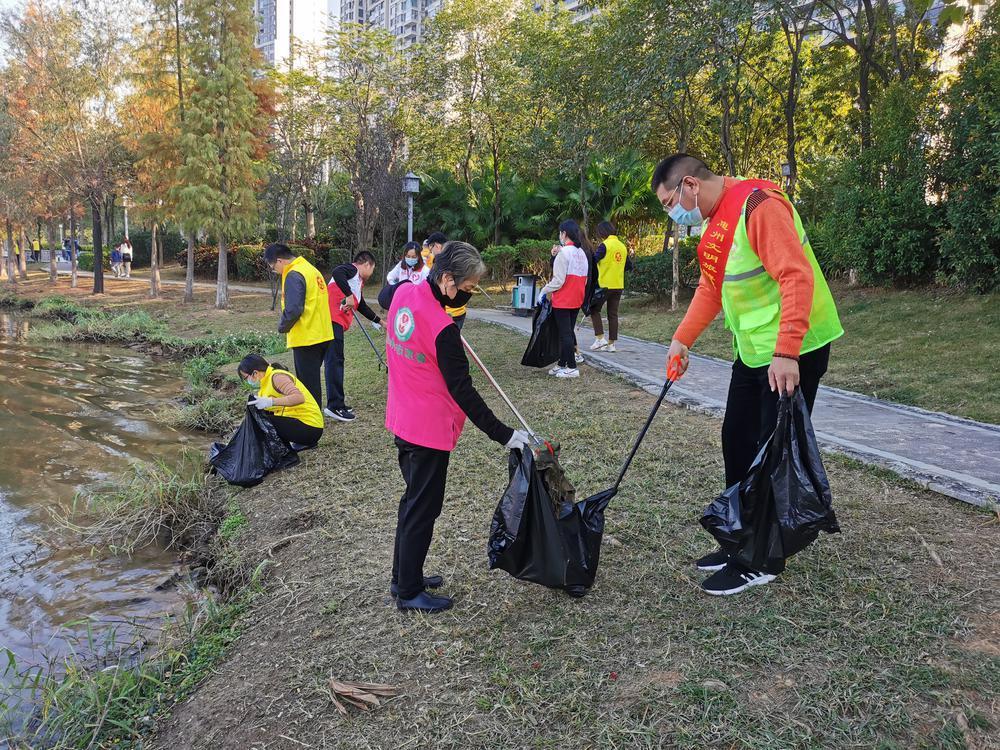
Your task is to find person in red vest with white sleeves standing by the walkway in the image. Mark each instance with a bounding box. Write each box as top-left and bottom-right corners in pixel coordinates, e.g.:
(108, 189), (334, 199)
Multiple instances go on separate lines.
(539, 219), (590, 378)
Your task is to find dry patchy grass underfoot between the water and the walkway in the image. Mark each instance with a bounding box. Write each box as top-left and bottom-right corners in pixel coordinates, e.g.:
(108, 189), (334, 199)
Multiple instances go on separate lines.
(148, 324), (1000, 750)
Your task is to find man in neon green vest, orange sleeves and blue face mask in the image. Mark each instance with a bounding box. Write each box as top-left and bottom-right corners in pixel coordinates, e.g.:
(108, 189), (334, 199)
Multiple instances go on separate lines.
(651, 154), (844, 595)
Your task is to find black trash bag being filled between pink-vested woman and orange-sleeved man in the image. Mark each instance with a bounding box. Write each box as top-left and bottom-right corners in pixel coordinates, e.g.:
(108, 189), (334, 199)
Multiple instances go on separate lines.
(487, 448), (610, 596)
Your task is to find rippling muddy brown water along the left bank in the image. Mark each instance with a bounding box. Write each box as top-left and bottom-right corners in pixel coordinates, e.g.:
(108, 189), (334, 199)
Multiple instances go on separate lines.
(0, 313), (193, 692)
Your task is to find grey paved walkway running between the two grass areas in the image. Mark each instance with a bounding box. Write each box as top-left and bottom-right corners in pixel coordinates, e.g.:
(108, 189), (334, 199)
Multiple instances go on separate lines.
(469, 308), (1000, 506)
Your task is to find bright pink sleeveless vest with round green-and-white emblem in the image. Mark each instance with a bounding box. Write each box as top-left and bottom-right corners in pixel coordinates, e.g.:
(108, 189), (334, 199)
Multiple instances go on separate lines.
(385, 283), (465, 451)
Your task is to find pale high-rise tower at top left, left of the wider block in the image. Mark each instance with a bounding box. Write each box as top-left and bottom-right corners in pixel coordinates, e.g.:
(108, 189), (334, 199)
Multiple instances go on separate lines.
(254, 0), (340, 66)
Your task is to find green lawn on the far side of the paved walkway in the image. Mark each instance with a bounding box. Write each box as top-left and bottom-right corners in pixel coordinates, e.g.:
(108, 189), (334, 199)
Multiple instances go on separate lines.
(596, 285), (1000, 424)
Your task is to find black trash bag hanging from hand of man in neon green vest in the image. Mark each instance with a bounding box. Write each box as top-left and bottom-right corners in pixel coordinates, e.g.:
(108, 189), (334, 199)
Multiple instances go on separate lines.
(701, 390), (840, 571)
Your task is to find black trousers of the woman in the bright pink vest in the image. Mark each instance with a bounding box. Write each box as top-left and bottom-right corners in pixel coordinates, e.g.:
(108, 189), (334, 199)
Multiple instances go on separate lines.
(392, 438), (451, 599)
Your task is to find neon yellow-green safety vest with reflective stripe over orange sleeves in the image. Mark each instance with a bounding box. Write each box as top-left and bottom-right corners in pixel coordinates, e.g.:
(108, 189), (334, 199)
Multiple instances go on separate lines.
(722, 189), (844, 367)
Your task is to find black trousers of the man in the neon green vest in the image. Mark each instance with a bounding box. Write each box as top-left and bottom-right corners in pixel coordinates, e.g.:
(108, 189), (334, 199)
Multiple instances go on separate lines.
(722, 344), (830, 487)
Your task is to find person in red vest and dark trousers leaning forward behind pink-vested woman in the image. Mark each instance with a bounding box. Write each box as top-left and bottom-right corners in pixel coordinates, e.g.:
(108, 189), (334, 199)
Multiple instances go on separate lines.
(323, 253), (382, 422)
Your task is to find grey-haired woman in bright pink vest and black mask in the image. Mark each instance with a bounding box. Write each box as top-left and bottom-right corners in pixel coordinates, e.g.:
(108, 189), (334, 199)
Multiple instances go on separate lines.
(385, 242), (529, 612)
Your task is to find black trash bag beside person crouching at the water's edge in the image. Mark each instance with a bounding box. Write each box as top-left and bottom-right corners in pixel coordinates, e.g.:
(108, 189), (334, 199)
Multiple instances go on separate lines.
(208, 404), (299, 487)
